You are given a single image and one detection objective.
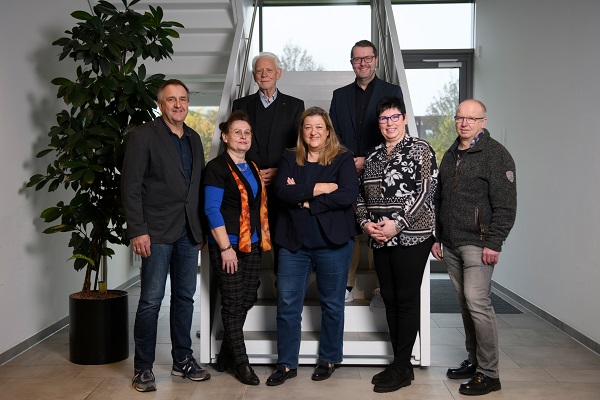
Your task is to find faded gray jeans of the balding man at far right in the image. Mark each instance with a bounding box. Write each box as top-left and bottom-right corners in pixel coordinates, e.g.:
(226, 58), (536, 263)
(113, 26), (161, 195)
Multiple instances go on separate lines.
(444, 245), (499, 378)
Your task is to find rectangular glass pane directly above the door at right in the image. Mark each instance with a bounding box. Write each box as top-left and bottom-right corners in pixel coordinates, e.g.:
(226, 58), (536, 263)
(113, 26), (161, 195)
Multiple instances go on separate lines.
(392, 3), (473, 50)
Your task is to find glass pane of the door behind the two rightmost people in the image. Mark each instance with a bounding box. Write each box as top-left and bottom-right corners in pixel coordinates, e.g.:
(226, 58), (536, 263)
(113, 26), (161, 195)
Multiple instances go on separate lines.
(406, 68), (459, 162)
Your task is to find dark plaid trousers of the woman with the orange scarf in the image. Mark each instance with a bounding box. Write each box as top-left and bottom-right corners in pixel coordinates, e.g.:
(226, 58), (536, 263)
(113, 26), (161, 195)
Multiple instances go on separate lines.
(208, 243), (261, 365)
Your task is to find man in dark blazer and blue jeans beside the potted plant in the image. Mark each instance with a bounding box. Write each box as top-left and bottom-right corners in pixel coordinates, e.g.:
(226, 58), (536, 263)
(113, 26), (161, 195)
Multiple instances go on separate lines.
(121, 79), (210, 392)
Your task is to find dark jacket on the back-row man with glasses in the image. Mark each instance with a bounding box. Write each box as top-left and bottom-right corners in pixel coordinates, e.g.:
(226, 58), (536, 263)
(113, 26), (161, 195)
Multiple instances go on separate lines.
(329, 76), (402, 157)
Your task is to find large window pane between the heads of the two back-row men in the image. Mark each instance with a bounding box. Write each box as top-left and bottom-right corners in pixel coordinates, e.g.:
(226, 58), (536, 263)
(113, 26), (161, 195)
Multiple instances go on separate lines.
(263, 5), (371, 71)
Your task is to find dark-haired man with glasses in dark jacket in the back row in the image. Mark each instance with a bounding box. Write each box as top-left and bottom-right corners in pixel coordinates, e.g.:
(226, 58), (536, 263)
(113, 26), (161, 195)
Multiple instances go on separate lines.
(329, 40), (402, 307)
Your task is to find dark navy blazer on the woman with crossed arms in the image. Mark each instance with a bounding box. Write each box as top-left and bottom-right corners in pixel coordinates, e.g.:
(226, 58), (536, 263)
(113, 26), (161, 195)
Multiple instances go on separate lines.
(269, 150), (358, 251)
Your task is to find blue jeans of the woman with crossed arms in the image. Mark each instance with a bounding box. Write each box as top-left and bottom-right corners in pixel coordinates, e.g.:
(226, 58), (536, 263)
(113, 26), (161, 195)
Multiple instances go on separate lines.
(277, 240), (354, 369)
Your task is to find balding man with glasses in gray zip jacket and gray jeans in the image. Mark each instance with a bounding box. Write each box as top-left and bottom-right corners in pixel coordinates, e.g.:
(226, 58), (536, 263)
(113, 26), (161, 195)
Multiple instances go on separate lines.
(431, 100), (517, 395)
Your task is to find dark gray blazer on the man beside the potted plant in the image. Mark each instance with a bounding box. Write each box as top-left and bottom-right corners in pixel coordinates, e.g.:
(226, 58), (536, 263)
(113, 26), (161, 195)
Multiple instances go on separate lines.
(121, 117), (204, 243)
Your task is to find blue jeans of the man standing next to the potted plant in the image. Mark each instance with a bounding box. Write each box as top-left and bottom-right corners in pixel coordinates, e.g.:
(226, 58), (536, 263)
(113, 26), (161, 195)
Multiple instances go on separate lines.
(133, 224), (200, 369)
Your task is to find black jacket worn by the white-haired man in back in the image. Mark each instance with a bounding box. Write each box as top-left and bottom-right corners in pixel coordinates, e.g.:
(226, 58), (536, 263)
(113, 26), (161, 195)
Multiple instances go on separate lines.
(232, 91), (304, 169)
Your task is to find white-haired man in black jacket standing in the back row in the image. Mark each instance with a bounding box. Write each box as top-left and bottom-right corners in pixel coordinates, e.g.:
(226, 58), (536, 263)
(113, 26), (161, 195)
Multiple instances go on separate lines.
(232, 52), (304, 273)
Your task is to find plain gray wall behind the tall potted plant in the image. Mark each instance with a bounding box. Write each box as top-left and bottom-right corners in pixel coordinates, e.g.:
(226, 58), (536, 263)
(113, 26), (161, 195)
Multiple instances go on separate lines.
(0, 0), (137, 354)
